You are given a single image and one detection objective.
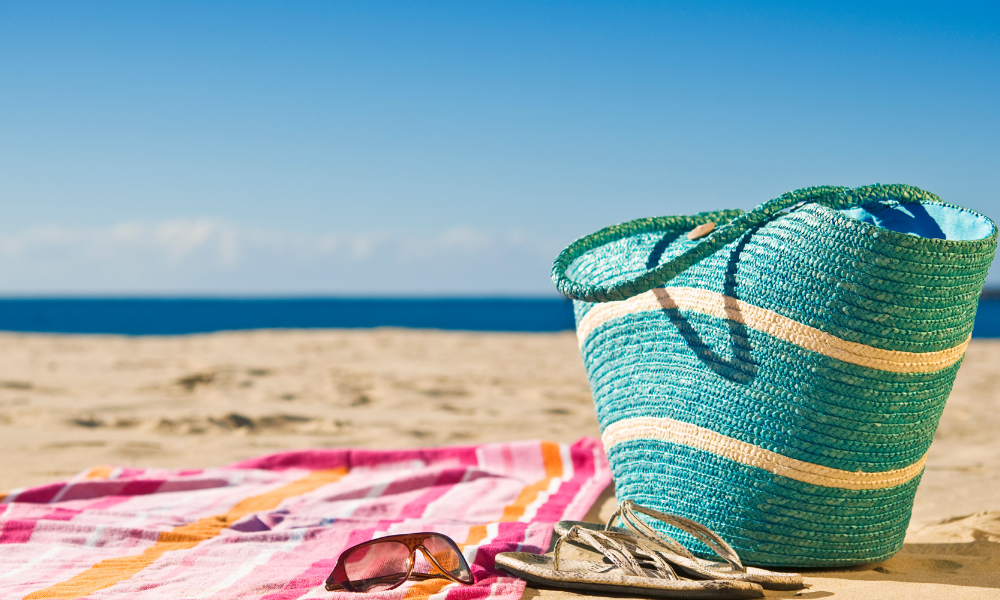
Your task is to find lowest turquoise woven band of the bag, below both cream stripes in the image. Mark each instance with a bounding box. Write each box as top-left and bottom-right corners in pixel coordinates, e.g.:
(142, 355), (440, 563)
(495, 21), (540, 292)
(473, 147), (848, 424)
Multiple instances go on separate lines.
(608, 443), (920, 567)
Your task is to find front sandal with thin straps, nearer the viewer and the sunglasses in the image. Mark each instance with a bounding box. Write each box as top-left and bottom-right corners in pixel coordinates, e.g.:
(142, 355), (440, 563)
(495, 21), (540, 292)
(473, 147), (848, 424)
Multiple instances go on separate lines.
(496, 527), (764, 598)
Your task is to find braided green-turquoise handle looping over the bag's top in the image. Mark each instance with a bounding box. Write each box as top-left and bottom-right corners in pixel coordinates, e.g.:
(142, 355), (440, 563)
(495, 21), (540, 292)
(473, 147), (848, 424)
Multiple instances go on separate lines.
(552, 184), (941, 302)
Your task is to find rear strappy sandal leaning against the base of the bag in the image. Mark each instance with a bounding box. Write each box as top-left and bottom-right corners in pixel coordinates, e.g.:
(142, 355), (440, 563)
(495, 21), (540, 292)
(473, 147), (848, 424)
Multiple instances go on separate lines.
(555, 500), (806, 590)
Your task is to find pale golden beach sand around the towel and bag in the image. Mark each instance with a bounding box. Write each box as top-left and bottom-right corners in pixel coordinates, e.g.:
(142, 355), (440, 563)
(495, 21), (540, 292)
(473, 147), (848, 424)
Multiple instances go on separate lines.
(0, 329), (1000, 600)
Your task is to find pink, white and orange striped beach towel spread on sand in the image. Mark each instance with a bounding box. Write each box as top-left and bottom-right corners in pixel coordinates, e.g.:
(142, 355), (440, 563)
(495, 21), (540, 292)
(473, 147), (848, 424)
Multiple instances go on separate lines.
(0, 438), (611, 600)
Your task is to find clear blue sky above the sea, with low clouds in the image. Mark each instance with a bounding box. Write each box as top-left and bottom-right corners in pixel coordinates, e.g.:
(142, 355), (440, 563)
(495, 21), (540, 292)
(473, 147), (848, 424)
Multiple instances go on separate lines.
(0, 0), (1000, 296)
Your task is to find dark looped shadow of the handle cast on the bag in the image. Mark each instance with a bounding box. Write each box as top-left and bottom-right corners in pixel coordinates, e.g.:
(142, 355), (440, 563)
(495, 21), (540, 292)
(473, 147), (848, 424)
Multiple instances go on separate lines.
(646, 226), (760, 385)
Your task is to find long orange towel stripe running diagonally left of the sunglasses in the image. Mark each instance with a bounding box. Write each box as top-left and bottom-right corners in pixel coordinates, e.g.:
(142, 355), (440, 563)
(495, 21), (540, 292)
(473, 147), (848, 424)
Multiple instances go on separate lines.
(24, 468), (347, 600)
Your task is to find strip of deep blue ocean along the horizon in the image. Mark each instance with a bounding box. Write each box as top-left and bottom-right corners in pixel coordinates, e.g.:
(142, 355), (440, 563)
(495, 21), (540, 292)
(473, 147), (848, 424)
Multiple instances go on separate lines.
(0, 297), (1000, 338)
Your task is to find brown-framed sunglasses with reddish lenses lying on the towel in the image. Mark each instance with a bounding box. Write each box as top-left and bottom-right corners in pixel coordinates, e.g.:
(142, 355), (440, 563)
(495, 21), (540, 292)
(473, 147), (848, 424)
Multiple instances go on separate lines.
(326, 532), (476, 592)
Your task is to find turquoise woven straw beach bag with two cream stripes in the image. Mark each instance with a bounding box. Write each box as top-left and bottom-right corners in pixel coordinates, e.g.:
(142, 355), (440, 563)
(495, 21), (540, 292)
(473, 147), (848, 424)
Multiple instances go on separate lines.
(553, 185), (997, 567)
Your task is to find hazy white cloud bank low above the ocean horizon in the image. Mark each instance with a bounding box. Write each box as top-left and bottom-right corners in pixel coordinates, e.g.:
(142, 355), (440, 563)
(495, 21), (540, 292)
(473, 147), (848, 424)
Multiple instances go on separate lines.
(0, 219), (559, 295)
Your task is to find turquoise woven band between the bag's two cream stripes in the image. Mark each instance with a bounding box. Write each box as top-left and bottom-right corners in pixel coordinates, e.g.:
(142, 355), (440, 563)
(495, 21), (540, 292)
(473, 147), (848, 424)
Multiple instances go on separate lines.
(584, 314), (958, 471)
